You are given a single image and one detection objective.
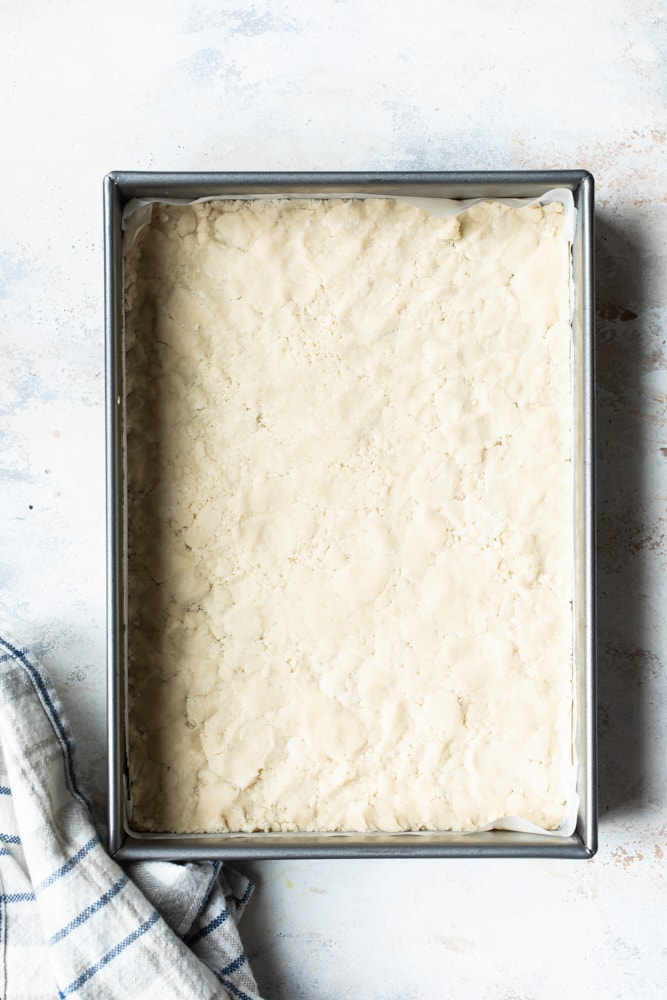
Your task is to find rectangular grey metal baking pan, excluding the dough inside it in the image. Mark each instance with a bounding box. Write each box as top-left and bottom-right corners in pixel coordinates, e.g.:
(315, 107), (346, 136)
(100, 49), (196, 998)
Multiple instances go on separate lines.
(104, 170), (597, 860)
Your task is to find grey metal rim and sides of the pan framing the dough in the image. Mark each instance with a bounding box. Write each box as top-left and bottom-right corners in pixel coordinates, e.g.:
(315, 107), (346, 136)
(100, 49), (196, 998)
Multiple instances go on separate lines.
(105, 170), (597, 860)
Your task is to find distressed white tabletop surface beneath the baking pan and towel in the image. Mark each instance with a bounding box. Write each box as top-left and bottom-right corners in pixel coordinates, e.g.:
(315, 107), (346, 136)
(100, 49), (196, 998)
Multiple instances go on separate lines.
(0, 0), (667, 1000)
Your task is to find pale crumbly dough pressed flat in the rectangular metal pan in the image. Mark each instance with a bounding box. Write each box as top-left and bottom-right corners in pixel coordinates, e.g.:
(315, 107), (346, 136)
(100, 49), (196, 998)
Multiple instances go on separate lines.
(126, 199), (573, 832)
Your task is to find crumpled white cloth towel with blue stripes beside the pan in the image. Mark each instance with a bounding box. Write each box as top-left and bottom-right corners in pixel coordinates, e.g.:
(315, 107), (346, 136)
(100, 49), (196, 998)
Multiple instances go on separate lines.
(0, 637), (260, 1000)
